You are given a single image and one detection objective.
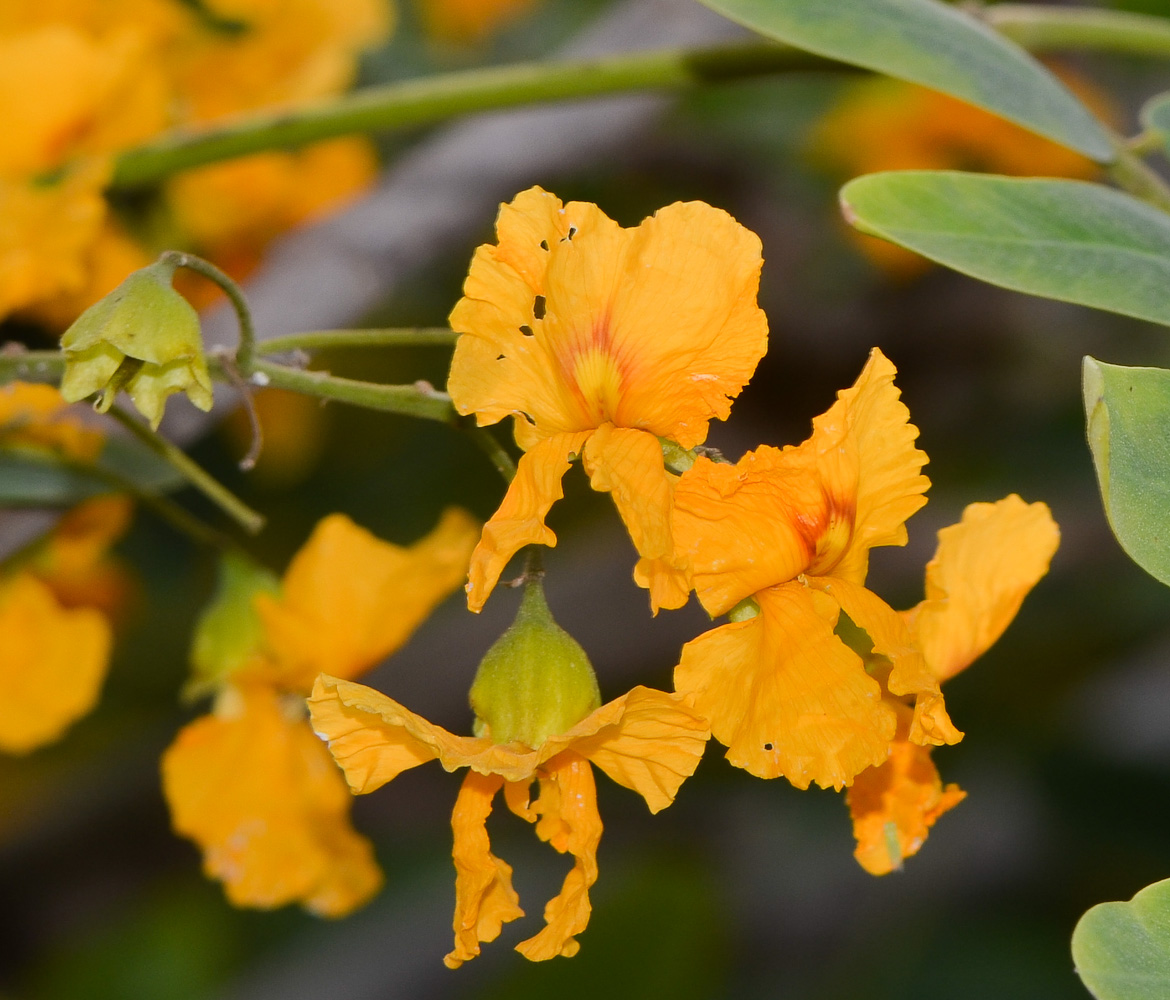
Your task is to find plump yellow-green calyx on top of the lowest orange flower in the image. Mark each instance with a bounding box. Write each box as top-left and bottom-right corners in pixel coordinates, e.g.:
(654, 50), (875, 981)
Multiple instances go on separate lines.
(472, 579), (601, 747)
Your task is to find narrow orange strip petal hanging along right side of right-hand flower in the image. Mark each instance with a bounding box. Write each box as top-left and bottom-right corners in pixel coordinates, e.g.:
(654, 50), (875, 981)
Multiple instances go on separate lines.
(807, 577), (963, 746)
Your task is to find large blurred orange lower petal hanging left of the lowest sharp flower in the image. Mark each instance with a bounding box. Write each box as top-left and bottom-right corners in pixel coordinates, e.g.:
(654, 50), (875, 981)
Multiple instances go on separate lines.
(163, 685), (381, 917)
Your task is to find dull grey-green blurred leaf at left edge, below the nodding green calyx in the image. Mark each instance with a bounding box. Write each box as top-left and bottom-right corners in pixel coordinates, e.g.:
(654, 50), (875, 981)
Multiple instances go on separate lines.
(0, 437), (184, 506)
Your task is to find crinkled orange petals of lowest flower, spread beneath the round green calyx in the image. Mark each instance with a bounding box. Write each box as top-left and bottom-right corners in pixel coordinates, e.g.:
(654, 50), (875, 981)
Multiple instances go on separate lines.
(309, 676), (709, 968)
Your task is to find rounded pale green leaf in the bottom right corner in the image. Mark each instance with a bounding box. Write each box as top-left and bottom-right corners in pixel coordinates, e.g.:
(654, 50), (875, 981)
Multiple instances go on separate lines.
(1073, 878), (1170, 1000)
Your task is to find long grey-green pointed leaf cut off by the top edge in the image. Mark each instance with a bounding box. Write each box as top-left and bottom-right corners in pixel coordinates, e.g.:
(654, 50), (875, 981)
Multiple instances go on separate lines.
(703, 0), (1115, 163)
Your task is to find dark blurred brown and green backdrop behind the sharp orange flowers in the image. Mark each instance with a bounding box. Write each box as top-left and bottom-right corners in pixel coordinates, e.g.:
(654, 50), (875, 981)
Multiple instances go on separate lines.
(0, 0), (1170, 1000)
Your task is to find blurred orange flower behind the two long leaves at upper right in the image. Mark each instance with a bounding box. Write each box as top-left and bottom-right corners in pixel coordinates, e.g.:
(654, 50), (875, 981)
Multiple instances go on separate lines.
(808, 69), (1116, 277)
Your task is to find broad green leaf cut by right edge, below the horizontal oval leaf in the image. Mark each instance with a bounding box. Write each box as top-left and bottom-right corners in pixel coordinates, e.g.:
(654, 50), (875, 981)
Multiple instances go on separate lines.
(1082, 358), (1170, 587)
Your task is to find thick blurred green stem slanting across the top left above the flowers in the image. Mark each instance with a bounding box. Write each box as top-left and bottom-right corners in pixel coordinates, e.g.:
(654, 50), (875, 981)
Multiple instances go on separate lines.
(111, 42), (839, 188)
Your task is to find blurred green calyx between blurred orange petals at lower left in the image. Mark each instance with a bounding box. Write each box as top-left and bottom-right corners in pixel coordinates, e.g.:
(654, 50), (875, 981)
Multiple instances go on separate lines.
(183, 553), (281, 701)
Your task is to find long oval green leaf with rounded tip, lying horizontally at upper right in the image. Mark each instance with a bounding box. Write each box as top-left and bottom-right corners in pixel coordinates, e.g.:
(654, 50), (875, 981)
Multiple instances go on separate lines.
(841, 171), (1170, 325)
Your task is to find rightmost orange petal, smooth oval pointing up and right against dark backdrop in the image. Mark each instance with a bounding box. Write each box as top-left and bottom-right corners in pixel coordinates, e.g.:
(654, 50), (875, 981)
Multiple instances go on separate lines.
(907, 494), (1060, 681)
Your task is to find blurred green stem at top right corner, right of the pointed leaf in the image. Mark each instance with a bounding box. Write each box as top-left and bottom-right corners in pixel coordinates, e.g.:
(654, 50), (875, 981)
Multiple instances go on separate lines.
(980, 4), (1170, 56)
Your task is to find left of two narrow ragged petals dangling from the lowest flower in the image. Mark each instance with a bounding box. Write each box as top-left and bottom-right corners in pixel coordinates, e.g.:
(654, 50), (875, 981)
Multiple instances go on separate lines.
(443, 771), (524, 968)
